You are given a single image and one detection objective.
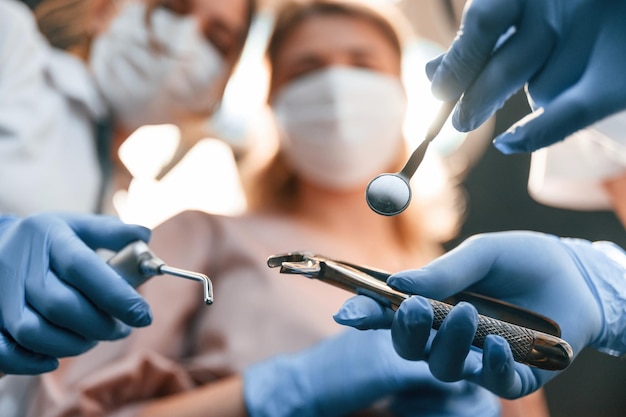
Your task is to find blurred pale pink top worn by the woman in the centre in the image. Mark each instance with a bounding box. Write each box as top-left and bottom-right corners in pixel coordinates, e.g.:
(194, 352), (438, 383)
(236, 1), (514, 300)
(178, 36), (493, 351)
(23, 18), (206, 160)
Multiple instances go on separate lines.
(28, 212), (428, 417)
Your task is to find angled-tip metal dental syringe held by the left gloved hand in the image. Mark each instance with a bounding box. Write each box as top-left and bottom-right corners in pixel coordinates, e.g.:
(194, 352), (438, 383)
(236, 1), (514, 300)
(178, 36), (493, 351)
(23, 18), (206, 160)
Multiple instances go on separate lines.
(107, 240), (213, 305)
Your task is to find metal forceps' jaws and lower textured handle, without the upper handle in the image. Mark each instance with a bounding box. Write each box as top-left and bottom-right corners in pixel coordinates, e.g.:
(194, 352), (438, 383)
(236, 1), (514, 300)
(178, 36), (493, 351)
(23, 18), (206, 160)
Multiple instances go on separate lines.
(268, 253), (573, 371)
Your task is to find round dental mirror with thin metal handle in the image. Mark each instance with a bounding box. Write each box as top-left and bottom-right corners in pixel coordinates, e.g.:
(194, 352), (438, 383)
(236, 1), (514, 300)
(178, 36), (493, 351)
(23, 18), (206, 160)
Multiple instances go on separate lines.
(365, 101), (456, 216)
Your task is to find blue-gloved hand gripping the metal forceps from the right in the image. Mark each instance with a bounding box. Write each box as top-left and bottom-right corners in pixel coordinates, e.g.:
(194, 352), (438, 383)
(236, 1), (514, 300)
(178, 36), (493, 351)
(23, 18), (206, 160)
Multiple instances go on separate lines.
(336, 232), (626, 398)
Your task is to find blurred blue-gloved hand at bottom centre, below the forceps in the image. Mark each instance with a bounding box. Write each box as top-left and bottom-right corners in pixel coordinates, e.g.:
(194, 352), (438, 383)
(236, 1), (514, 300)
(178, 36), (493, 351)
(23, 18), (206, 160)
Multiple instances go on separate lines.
(244, 329), (500, 417)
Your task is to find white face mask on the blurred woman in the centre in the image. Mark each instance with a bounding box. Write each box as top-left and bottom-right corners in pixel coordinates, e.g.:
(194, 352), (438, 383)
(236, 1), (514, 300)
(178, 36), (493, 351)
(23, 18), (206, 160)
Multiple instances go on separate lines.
(272, 67), (406, 190)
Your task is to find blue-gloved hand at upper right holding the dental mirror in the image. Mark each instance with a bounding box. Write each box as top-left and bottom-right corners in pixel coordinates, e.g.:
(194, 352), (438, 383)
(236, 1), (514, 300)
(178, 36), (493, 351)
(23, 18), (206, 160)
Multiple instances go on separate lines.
(426, 0), (626, 153)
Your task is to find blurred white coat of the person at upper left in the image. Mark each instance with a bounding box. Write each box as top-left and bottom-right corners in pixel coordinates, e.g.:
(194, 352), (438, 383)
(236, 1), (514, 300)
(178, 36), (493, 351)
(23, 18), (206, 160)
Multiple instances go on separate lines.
(0, 0), (107, 215)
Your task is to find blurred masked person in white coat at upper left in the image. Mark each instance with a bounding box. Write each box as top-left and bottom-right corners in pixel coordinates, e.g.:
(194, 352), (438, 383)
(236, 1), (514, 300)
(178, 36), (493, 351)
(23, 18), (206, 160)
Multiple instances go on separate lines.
(0, 0), (254, 215)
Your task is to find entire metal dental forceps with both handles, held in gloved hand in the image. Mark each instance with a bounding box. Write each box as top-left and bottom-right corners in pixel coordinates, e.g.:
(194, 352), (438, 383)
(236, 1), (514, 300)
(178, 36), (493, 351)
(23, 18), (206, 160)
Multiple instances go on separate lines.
(267, 252), (574, 371)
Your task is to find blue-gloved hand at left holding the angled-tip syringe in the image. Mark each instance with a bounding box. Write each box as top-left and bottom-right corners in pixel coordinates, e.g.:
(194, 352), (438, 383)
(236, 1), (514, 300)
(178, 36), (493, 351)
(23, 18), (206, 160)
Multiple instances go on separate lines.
(0, 214), (152, 374)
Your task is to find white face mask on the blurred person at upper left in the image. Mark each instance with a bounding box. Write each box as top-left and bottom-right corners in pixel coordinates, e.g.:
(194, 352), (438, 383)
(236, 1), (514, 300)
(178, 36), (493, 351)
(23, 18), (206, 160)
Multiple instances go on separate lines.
(89, 2), (226, 129)
